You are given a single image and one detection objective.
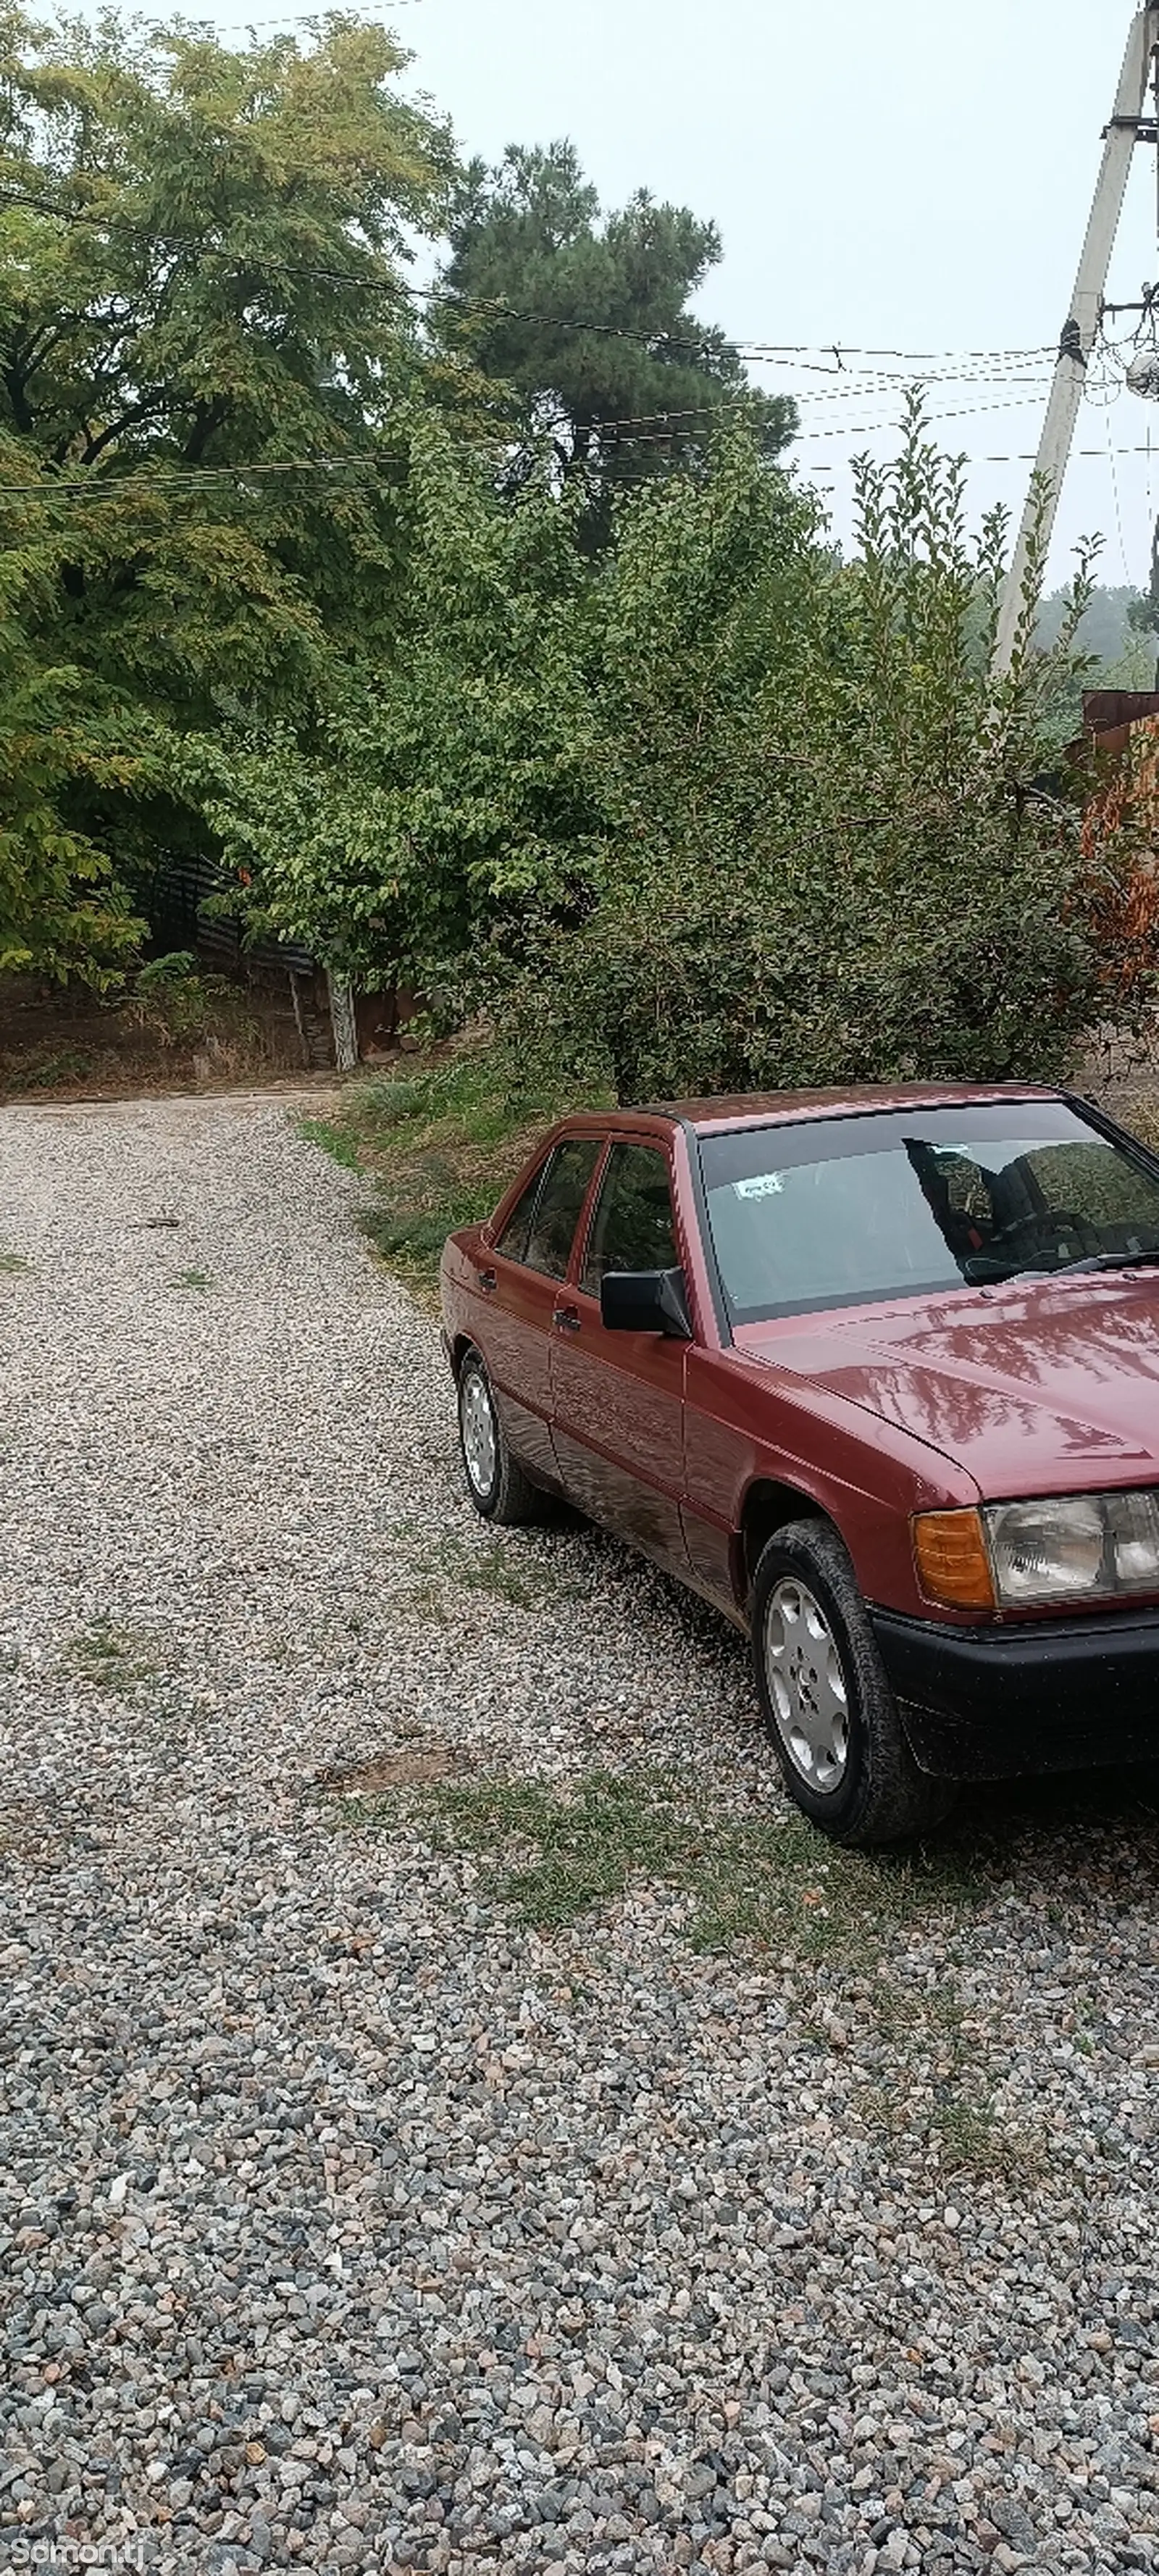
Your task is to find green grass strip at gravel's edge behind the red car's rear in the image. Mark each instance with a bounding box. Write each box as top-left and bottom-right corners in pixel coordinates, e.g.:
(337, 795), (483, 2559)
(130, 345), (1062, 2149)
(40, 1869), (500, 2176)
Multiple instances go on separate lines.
(298, 1043), (608, 1288)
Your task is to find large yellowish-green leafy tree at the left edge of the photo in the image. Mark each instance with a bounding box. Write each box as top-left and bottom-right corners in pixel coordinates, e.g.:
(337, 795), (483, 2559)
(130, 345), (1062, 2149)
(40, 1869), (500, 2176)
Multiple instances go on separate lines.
(0, 10), (453, 958)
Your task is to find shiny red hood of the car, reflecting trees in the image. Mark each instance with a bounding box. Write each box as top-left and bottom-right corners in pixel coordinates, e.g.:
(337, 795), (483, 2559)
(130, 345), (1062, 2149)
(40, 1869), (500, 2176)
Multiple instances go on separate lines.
(737, 1270), (1159, 1494)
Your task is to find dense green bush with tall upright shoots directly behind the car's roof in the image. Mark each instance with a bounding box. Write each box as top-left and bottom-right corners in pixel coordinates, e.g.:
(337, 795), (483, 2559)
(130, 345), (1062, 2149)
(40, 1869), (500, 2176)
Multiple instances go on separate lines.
(494, 404), (1154, 1100)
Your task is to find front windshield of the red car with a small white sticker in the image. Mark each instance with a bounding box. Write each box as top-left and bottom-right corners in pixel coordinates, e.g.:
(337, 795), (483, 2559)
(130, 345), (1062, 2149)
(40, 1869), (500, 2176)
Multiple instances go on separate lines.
(700, 1100), (1159, 1324)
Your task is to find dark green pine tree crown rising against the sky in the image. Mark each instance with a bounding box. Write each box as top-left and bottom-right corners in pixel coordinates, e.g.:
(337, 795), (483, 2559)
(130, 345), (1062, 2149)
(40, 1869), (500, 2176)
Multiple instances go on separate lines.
(438, 142), (796, 535)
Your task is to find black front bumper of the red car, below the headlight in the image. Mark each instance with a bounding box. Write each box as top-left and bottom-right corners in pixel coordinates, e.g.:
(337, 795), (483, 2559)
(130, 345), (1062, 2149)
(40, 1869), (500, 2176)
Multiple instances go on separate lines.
(871, 1610), (1159, 1780)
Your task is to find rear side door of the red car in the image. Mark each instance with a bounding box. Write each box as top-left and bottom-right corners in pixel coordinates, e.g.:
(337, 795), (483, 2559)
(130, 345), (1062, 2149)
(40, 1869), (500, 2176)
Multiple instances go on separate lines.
(479, 1136), (603, 1484)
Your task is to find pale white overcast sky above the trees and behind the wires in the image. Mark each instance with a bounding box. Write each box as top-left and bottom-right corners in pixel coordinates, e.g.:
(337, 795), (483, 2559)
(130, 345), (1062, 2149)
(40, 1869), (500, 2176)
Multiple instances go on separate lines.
(212, 0), (1159, 588)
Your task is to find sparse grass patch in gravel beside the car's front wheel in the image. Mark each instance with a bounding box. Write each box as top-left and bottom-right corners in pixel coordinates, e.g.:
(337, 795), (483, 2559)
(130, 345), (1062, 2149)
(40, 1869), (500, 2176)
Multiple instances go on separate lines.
(319, 1770), (1043, 2190)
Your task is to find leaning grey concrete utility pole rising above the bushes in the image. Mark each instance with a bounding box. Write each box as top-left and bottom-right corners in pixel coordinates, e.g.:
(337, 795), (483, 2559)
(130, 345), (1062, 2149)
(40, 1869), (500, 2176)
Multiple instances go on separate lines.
(994, 5), (1159, 678)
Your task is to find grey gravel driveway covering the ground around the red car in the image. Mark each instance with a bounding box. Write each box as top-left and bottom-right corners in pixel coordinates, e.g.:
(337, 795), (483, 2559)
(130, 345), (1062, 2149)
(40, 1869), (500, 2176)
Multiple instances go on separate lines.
(0, 1100), (1159, 2576)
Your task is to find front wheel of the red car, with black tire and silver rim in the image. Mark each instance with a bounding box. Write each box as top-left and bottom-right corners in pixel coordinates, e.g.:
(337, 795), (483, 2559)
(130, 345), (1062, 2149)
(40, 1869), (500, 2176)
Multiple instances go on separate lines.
(752, 1520), (955, 1849)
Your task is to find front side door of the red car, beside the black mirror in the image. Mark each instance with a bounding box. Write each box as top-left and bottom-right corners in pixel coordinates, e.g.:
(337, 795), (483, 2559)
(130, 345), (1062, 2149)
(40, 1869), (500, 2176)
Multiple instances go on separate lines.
(551, 1138), (687, 1572)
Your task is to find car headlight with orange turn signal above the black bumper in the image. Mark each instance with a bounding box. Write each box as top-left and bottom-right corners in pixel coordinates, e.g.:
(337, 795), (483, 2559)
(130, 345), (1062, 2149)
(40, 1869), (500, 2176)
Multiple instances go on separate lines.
(914, 1491), (1159, 1610)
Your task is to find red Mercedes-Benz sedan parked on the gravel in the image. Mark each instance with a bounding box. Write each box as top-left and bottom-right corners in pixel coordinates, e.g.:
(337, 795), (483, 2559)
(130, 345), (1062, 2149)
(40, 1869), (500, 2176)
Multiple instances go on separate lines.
(443, 1085), (1159, 1844)
